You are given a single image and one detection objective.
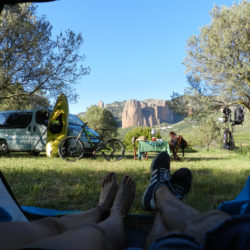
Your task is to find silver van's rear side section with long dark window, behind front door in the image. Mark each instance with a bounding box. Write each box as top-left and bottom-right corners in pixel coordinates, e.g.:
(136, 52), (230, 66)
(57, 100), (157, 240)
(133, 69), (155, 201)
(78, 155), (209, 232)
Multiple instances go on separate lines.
(0, 111), (32, 151)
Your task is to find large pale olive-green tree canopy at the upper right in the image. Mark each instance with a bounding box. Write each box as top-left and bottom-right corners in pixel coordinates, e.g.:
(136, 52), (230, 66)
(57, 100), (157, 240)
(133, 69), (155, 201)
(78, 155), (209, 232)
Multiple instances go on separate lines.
(184, 0), (250, 110)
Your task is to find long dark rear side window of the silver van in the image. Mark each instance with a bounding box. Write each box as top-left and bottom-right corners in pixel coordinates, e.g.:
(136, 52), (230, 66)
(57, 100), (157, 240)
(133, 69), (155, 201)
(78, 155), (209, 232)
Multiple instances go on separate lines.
(0, 112), (32, 128)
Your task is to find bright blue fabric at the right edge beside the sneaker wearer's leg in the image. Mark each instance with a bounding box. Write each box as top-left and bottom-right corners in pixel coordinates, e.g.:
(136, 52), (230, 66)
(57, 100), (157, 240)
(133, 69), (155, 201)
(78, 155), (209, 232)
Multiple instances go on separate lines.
(218, 176), (250, 216)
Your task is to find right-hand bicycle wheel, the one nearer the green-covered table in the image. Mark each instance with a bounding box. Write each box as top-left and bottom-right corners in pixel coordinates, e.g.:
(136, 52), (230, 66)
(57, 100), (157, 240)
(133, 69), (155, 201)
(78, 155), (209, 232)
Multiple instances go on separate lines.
(101, 139), (125, 161)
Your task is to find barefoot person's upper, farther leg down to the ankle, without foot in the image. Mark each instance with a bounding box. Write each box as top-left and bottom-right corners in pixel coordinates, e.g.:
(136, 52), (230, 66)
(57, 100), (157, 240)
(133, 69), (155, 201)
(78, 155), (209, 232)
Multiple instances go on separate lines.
(0, 208), (101, 249)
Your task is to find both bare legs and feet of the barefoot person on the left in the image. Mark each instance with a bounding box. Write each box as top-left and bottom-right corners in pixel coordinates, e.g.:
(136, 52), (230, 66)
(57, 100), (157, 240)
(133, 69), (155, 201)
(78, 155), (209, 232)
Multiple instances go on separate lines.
(0, 173), (135, 249)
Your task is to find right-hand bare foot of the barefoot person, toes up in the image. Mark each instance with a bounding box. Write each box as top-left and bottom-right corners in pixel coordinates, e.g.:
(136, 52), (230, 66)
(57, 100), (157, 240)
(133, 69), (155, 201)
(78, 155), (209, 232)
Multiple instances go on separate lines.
(111, 175), (136, 216)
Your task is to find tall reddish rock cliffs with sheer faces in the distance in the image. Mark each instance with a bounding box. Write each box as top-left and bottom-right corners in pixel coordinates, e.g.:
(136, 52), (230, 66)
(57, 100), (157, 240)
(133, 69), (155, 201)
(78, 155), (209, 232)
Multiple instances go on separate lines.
(122, 99), (185, 128)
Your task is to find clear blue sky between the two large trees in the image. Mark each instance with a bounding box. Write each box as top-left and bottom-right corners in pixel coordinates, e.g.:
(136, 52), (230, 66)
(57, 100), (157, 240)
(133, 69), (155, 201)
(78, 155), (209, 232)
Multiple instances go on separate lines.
(38, 0), (237, 114)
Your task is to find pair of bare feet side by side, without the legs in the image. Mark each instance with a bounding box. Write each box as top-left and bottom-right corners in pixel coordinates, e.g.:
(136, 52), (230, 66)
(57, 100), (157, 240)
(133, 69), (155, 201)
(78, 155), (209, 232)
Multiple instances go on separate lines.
(98, 172), (136, 216)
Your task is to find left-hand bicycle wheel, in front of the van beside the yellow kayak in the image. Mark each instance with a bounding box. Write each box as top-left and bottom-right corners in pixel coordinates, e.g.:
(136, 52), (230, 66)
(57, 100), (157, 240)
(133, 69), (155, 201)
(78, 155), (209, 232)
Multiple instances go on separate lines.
(58, 136), (85, 161)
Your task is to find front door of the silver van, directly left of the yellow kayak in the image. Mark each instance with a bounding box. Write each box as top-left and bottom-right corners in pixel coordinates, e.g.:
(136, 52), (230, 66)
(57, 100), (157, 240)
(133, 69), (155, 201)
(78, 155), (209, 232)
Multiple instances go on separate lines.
(31, 110), (49, 152)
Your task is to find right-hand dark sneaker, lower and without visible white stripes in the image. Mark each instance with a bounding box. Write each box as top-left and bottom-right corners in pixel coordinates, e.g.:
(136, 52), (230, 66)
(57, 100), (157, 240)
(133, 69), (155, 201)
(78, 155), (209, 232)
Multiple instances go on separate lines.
(171, 168), (192, 200)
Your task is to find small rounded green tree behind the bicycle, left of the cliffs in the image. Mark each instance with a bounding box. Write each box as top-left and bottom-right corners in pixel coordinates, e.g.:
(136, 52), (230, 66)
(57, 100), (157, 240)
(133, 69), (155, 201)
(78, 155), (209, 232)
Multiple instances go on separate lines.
(82, 105), (118, 139)
